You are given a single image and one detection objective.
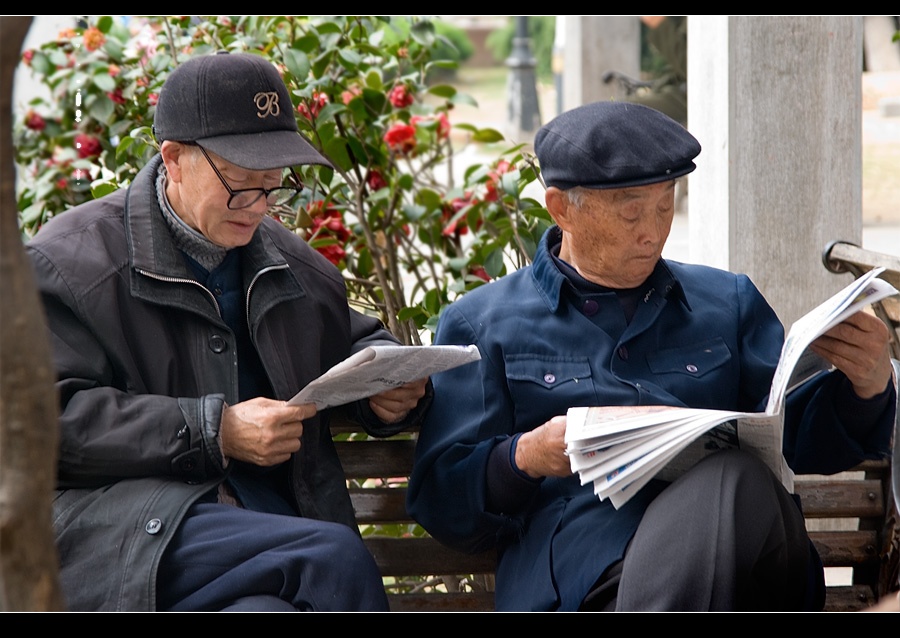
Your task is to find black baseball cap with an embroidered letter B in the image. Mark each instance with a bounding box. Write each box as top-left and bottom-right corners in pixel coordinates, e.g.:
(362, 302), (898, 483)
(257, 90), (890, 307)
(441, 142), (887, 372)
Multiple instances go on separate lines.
(153, 51), (331, 170)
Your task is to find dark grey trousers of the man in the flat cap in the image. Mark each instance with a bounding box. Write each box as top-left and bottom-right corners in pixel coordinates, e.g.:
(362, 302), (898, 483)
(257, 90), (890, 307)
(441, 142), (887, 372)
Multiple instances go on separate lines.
(583, 450), (825, 611)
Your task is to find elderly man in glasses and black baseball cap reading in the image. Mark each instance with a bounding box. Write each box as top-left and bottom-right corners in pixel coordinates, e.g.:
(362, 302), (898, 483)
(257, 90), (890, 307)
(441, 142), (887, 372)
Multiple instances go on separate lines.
(27, 54), (431, 611)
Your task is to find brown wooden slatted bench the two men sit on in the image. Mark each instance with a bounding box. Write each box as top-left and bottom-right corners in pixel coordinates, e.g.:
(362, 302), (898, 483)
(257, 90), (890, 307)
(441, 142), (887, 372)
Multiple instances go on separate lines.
(332, 244), (900, 612)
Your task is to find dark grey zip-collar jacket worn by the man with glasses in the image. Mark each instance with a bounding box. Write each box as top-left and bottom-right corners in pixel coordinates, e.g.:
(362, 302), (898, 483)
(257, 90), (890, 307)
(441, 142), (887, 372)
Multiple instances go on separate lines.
(27, 156), (430, 610)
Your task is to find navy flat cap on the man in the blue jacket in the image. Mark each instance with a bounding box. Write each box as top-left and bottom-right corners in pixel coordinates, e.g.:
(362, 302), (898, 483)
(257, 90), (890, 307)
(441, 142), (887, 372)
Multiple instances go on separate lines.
(534, 102), (700, 190)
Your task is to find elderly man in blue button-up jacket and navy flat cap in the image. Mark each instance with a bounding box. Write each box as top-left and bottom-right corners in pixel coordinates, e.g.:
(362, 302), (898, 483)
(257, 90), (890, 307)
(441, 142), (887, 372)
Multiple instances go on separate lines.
(407, 102), (896, 611)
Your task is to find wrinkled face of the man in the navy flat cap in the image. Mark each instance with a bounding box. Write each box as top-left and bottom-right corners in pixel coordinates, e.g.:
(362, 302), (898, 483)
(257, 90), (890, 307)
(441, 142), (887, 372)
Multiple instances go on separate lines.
(548, 180), (675, 288)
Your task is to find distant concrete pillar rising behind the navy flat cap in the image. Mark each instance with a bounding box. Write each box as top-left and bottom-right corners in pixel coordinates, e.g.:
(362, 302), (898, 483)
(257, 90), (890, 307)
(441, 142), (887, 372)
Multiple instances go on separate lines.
(557, 16), (641, 111)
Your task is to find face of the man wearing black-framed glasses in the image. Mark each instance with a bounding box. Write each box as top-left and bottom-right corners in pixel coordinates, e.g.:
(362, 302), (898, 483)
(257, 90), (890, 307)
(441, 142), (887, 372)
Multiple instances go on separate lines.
(167, 145), (282, 248)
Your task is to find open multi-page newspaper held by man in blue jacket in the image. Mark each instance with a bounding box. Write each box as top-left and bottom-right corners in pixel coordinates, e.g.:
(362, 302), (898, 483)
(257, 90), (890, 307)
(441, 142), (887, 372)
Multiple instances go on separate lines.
(566, 268), (898, 509)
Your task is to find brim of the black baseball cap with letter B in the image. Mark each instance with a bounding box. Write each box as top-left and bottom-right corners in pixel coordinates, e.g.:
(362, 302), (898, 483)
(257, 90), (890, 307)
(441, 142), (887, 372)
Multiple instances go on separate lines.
(197, 131), (332, 171)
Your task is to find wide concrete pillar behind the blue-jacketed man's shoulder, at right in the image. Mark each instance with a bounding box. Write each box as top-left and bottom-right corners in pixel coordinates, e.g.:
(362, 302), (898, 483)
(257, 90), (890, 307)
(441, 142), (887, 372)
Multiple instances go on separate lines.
(688, 16), (863, 328)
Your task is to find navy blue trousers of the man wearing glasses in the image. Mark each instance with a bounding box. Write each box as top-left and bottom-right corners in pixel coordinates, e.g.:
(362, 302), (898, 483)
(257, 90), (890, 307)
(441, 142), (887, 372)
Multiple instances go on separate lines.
(157, 503), (388, 611)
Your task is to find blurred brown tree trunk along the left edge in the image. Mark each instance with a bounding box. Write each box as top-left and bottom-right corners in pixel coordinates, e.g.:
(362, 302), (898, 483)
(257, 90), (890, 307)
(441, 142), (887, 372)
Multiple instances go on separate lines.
(0, 16), (64, 611)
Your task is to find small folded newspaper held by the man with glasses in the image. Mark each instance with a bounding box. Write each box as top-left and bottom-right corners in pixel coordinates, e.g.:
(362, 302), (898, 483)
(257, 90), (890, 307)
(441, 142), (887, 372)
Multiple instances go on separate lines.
(288, 345), (481, 410)
